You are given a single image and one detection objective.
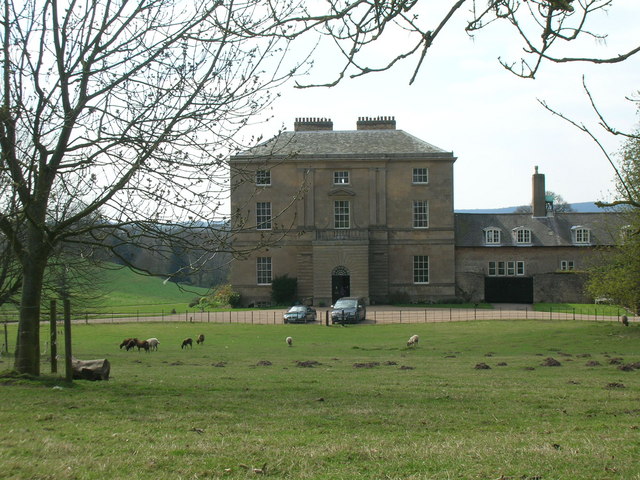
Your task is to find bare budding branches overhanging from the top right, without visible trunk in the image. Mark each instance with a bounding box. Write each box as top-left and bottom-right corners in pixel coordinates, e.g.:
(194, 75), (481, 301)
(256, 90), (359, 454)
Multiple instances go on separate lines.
(287, 0), (640, 88)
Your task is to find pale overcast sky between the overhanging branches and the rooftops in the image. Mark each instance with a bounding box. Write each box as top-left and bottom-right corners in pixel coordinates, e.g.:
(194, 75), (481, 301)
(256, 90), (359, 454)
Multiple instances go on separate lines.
(255, 1), (640, 209)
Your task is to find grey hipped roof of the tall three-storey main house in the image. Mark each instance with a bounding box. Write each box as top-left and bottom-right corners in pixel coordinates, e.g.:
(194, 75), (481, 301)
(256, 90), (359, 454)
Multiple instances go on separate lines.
(233, 129), (455, 160)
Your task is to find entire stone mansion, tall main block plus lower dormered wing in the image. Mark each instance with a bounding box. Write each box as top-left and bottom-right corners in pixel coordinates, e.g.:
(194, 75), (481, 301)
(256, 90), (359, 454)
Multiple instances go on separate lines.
(230, 117), (617, 305)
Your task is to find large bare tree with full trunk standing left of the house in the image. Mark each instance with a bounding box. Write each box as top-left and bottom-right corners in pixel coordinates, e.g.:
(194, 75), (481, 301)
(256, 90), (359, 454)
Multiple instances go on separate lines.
(0, 0), (312, 375)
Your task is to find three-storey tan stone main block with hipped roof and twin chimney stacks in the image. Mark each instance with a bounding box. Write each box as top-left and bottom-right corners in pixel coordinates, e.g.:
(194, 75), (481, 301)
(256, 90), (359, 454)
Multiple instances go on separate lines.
(230, 117), (455, 305)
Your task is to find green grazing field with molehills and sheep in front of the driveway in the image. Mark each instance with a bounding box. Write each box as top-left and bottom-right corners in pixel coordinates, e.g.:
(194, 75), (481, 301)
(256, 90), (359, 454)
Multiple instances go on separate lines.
(0, 321), (640, 480)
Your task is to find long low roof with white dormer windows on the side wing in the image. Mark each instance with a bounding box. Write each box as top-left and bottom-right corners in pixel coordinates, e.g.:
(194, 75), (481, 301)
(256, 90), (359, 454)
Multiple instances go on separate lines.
(455, 212), (626, 247)
